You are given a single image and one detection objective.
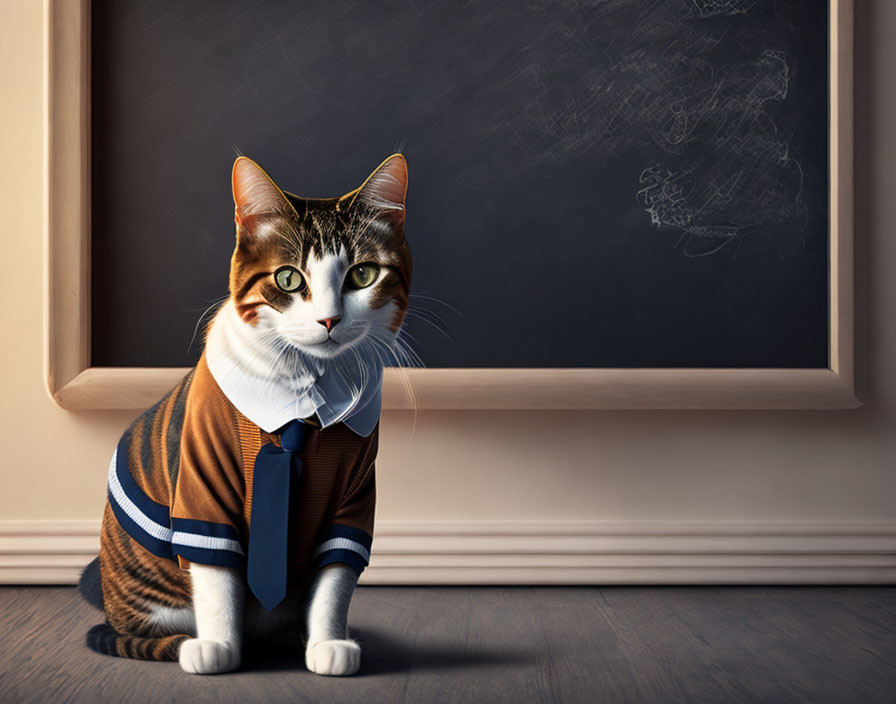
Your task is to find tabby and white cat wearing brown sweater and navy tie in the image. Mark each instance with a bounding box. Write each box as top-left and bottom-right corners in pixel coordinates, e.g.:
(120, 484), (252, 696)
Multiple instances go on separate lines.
(82, 154), (411, 675)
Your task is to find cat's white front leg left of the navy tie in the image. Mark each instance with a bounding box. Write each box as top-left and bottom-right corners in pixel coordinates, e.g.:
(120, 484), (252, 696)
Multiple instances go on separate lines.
(179, 563), (244, 675)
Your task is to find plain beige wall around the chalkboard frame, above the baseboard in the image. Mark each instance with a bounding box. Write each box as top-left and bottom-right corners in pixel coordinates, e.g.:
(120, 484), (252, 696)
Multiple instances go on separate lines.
(0, 0), (896, 540)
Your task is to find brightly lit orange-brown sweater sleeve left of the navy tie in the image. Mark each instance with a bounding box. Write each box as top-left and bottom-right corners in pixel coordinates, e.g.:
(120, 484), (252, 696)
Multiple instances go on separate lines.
(171, 360), (246, 569)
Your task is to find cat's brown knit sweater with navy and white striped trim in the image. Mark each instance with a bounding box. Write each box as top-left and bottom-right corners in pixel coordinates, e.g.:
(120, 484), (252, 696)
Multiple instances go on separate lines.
(103, 354), (380, 612)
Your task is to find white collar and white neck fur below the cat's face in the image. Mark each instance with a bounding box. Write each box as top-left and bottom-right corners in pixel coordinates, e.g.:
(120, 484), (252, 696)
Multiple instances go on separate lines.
(205, 301), (383, 437)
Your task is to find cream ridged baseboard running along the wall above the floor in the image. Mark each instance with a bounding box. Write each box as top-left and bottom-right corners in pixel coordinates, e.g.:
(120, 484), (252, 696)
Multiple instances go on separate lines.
(0, 520), (896, 585)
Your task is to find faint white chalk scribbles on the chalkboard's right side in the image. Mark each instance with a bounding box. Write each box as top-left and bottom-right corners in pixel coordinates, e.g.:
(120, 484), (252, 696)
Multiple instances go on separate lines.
(611, 0), (806, 256)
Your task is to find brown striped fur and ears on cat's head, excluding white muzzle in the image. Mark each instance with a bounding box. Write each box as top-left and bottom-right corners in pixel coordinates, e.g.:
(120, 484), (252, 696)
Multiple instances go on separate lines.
(230, 154), (412, 338)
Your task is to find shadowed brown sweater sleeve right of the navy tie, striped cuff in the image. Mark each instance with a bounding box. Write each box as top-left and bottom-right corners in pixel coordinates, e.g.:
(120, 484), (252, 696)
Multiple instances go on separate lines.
(313, 428), (376, 575)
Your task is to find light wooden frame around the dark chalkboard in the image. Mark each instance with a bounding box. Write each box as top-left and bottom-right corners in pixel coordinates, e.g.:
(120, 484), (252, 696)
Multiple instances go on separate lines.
(44, 0), (861, 409)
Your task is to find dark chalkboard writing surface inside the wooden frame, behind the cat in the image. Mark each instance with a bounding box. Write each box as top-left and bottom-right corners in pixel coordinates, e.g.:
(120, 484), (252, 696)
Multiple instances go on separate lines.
(91, 0), (829, 367)
